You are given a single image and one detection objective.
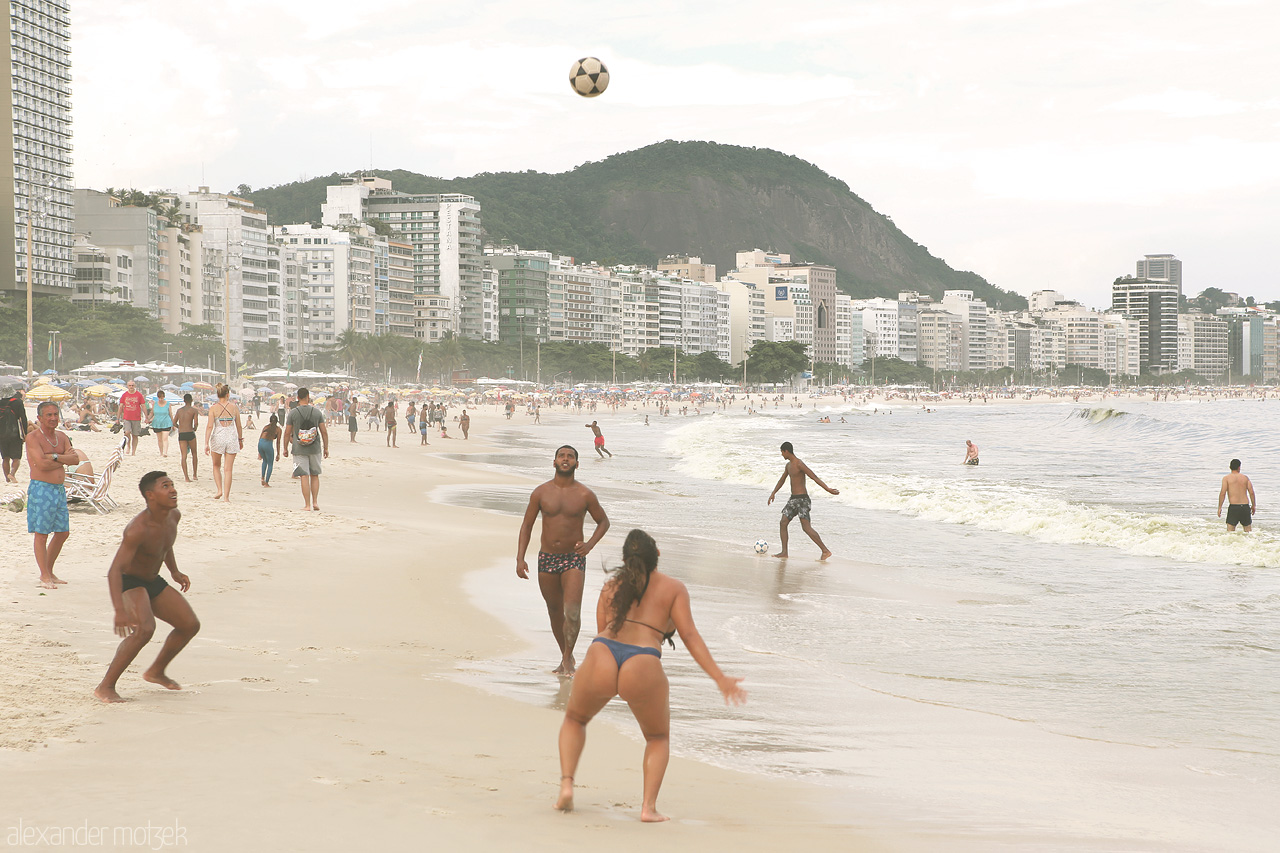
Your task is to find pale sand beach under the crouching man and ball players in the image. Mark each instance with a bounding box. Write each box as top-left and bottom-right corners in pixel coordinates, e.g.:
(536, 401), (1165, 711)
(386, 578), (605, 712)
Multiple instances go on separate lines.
(0, 409), (931, 850)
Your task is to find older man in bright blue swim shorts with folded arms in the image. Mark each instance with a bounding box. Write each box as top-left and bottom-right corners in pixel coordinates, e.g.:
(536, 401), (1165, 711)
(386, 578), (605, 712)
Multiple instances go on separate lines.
(24, 401), (88, 589)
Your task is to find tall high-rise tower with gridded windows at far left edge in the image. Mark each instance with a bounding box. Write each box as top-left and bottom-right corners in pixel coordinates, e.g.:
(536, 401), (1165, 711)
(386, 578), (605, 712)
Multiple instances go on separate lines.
(0, 0), (74, 297)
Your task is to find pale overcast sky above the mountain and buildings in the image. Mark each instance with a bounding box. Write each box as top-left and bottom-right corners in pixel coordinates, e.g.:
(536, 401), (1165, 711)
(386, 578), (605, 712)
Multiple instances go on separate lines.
(72, 0), (1280, 306)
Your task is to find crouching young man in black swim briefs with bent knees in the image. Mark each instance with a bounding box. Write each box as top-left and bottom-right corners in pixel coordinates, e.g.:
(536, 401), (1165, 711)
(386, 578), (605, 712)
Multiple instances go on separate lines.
(93, 471), (200, 702)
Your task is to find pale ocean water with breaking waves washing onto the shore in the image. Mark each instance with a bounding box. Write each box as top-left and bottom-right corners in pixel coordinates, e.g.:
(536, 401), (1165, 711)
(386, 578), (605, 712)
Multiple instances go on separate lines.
(445, 398), (1280, 850)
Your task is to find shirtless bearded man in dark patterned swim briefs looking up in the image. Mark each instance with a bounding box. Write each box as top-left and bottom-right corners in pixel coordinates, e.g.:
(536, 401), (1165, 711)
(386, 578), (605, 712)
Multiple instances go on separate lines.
(516, 444), (609, 678)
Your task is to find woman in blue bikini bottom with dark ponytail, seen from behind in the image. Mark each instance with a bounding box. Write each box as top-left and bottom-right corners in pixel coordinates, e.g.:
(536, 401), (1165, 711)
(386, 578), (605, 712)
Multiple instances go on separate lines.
(556, 530), (746, 822)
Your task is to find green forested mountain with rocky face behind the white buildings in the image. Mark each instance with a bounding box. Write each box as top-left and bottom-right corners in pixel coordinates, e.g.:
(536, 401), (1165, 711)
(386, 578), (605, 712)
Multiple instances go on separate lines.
(248, 141), (1027, 310)
